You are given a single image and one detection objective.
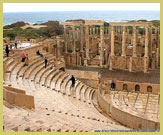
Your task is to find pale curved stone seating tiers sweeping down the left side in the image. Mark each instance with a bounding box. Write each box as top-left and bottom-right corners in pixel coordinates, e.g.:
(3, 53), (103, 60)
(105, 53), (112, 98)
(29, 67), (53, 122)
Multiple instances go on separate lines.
(3, 48), (129, 132)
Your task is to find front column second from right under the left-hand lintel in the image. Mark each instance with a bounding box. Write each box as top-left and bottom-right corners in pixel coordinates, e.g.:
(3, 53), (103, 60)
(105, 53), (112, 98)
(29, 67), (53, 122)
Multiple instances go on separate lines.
(85, 25), (89, 59)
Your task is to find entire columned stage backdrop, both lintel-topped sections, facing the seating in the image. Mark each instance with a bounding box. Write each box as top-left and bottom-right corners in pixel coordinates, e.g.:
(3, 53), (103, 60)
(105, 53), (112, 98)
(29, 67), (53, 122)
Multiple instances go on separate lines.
(62, 20), (159, 72)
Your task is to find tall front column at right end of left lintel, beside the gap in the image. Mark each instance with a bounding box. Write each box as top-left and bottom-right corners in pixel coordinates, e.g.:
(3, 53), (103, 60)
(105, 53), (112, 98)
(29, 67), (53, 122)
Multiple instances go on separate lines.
(100, 26), (104, 66)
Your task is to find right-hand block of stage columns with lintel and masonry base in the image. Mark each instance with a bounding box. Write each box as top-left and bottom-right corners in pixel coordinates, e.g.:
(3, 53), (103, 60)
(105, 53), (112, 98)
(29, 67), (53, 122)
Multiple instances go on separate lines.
(110, 22), (159, 73)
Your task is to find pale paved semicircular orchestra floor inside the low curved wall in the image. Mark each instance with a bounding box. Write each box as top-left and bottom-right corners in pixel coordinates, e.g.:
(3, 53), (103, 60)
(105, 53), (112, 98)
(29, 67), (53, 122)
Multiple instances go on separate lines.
(107, 91), (160, 121)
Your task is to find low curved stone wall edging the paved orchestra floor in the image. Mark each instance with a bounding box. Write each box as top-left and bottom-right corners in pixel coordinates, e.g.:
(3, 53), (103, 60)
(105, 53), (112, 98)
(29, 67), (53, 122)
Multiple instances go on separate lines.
(97, 87), (160, 130)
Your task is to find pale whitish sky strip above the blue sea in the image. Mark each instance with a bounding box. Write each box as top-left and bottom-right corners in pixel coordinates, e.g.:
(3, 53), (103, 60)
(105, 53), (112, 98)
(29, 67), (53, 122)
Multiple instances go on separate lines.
(3, 3), (160, 12)
